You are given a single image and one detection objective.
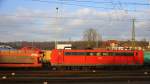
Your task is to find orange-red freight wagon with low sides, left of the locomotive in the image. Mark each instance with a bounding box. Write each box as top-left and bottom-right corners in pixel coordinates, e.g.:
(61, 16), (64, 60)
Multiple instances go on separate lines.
(0, 49), (42, 67)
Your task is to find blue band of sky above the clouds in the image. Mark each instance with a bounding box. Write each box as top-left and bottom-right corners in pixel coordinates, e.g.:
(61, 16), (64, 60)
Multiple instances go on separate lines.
(1, 0), (150, 13)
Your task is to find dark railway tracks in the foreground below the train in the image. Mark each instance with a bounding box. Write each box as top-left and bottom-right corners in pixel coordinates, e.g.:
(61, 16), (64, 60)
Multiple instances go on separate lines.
(0, 70), (150, 84)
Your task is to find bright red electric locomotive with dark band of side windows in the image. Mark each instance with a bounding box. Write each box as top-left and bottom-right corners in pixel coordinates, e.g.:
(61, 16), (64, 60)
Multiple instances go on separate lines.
(50, 49), (144, 66)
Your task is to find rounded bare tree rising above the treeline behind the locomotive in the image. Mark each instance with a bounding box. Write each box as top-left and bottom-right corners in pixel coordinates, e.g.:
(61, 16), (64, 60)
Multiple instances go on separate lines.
(83, 28), (101, 48)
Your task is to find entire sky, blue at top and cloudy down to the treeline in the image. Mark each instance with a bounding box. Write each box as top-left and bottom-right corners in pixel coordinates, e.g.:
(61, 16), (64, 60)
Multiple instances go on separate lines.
(0, 0), (150, 42)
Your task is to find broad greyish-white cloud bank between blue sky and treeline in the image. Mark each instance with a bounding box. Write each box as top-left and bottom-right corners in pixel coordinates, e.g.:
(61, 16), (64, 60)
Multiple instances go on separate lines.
(0, 8), (150, 41)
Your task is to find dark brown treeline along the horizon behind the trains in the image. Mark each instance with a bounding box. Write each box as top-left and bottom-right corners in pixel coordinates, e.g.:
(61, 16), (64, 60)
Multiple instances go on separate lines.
(0, 41), (148, 50)
